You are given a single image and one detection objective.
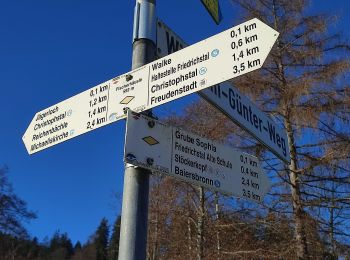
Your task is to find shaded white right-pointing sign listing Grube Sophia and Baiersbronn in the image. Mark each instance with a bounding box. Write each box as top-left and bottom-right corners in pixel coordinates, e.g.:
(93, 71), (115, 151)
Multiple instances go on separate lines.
(124, 112), (270, 202)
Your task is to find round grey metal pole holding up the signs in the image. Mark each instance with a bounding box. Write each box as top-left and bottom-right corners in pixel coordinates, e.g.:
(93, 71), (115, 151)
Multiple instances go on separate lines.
(119, 0), (156, 260)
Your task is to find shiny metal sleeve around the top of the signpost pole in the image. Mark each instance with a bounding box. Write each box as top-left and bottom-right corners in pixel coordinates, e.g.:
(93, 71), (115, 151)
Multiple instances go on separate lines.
(132, 0), (157, 43)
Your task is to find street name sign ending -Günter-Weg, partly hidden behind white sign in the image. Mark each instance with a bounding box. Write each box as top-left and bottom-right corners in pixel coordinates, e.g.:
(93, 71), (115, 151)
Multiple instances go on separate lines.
(157, 20), (290, 163)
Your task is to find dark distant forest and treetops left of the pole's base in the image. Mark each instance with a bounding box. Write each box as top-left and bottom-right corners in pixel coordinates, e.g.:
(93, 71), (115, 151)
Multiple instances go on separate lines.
(0, 166), (120, 260)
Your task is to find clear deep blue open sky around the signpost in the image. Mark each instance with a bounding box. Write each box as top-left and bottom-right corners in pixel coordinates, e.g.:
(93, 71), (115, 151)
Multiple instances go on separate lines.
(0, 0), (350, 242)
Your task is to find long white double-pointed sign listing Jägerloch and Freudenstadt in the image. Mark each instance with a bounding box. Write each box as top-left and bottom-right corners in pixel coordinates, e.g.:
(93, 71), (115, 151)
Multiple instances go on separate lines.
(23, 19), (278, 154)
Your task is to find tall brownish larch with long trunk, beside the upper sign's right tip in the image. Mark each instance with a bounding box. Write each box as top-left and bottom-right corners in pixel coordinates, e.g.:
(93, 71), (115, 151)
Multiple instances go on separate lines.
(228, 0), (350, 259)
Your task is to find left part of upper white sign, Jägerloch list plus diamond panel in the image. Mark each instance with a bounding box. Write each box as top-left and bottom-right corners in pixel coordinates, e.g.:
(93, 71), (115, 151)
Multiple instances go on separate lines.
(23, 67), (148, 154)
